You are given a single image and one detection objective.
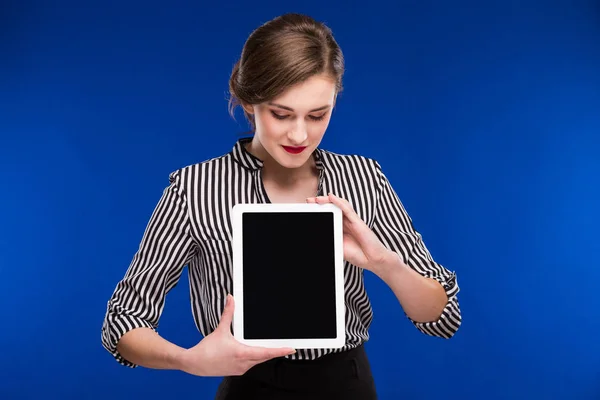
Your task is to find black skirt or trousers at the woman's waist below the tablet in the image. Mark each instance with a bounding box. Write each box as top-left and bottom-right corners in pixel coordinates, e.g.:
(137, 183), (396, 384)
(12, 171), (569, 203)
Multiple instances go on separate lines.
(215, 346), (377, 400)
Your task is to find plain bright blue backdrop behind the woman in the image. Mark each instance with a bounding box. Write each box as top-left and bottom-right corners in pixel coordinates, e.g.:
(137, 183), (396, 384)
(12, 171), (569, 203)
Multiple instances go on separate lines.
(0, 0), (600, 400)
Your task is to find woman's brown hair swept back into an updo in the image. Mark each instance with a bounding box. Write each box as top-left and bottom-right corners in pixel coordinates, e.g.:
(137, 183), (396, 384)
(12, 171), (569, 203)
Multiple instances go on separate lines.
(229, 13), (344, 131)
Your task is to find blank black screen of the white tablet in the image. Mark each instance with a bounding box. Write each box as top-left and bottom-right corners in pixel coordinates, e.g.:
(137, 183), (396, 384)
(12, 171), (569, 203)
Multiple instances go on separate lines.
(242, 212), (337, 339)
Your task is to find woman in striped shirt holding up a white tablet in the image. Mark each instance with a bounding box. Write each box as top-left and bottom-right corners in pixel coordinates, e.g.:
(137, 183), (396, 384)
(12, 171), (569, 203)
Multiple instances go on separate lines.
(102, 14), (461, 400)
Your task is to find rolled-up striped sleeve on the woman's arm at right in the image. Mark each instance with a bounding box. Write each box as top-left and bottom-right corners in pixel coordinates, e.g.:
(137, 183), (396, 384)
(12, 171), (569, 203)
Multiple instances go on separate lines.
(373, 162), (461, 339)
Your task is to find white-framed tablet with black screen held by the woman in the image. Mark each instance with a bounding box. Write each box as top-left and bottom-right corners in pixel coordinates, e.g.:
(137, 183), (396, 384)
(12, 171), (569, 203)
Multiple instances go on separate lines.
(232, 203), (346, 349)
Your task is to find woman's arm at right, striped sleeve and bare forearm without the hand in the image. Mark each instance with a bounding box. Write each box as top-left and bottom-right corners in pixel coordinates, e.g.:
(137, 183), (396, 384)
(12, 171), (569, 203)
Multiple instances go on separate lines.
(373, 163), (462, 338)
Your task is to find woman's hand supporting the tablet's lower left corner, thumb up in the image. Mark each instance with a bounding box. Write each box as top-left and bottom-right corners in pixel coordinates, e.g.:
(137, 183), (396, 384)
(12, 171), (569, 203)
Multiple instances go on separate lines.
(179, 295), (296, 376)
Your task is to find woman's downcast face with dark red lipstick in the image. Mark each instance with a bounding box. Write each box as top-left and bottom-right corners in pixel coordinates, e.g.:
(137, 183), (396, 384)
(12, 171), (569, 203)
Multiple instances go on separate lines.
(245, 75), (336, 168)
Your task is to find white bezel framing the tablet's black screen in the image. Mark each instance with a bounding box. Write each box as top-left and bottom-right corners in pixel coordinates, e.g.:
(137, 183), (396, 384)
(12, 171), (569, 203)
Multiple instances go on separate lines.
(232, 203), (346, 349)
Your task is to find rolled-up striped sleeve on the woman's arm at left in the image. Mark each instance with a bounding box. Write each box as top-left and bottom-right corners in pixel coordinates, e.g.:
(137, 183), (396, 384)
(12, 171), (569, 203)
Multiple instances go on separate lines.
(101, 170), (194, 368)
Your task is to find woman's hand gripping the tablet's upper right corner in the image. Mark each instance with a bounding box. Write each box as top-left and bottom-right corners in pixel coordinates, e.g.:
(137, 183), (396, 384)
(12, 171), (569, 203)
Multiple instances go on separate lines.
(306, 194), (390, 272)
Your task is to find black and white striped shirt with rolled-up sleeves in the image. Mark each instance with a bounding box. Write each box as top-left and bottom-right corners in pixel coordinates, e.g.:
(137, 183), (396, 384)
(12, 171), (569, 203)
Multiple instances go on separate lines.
(102, 138), (461, 367)
